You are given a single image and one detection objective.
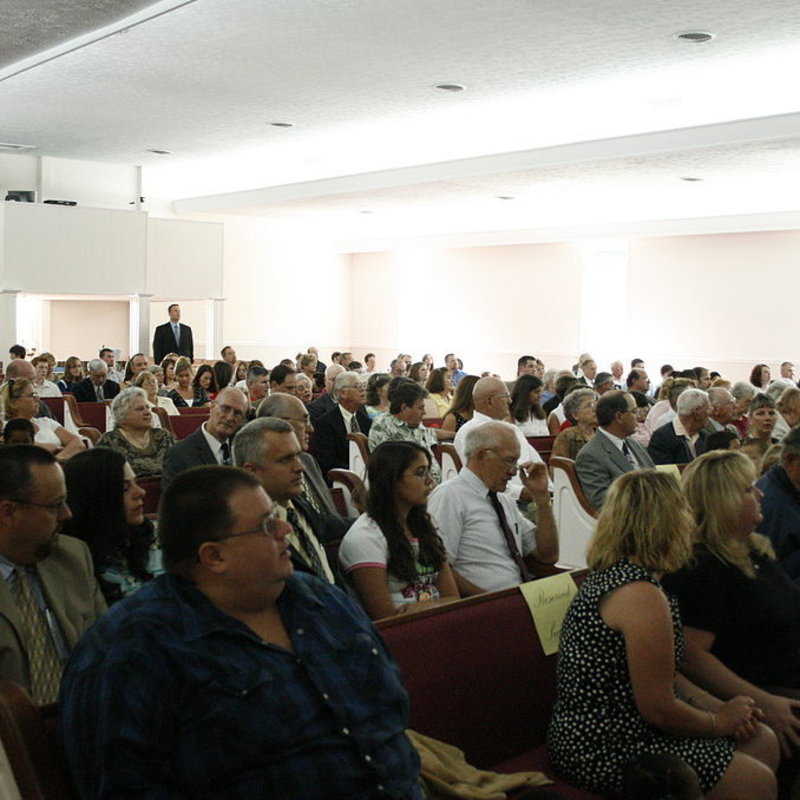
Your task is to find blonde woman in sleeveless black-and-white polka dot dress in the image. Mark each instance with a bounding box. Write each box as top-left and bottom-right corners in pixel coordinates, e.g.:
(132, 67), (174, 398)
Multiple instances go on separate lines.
(548, 470), (778, 800)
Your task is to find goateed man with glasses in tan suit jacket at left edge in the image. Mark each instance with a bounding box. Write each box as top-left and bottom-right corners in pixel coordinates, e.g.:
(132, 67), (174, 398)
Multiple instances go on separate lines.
(0, 445), (106, 704)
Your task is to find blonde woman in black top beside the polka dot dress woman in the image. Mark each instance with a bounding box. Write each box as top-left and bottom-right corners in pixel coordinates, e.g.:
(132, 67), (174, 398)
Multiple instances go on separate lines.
(664, 450), (800, 764)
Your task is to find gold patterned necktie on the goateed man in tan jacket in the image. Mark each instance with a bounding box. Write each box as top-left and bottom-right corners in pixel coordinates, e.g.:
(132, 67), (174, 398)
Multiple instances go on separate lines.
(11, 567), (61, 705)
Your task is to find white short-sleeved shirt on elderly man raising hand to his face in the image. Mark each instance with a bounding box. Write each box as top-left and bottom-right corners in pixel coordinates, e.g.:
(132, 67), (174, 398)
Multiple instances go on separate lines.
(428, 467), (536, 592)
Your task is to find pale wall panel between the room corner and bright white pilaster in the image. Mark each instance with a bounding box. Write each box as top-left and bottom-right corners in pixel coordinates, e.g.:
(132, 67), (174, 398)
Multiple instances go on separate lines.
(351, 244), (581, 377)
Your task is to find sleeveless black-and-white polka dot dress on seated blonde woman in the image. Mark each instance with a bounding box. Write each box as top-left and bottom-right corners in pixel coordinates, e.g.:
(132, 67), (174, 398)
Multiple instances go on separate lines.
(548, 560), (735, 794)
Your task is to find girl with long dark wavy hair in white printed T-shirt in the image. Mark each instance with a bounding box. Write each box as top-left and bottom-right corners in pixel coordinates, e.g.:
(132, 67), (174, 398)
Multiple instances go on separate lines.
(339, 441), (458, 619)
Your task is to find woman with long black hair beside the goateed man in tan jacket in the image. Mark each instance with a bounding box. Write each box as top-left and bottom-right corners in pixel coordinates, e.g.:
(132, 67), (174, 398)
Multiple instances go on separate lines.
(62, 447), (159, 605)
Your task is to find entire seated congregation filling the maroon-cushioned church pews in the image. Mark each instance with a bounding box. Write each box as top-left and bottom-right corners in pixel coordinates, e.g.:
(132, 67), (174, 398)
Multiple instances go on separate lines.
(0, 346), (800, 800)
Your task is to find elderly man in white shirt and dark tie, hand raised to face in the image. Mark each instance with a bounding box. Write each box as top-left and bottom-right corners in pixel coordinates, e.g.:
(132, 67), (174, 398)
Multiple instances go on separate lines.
(428, 422), (558, 596)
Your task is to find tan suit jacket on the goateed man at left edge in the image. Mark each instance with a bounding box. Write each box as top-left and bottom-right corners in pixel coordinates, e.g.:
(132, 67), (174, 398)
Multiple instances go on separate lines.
(0, 534), (106, 691)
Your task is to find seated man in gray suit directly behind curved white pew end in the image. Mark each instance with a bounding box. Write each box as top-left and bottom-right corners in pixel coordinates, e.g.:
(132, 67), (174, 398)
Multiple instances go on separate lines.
(575, 392), (653, 509)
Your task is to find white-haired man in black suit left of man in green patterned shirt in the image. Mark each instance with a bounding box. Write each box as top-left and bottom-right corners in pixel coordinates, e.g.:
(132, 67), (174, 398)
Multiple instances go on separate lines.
(311, 372), (372, 480)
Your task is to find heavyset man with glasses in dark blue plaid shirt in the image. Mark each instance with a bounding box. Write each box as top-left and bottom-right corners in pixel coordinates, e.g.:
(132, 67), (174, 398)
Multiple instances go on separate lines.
(61, 466), (422, 800)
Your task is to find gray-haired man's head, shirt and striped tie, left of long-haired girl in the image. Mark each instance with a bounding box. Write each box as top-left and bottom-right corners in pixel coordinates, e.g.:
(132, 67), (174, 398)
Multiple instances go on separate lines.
(233, 417), (344, 587)
